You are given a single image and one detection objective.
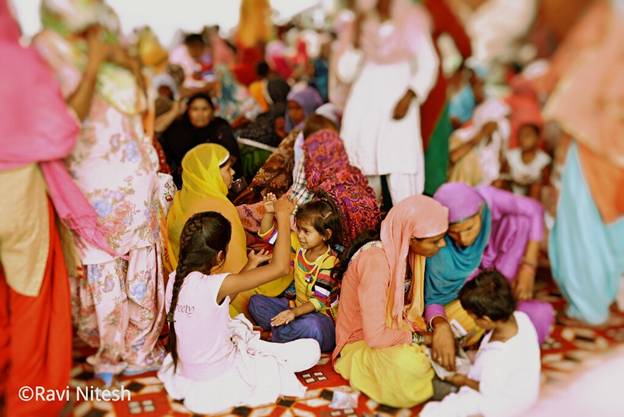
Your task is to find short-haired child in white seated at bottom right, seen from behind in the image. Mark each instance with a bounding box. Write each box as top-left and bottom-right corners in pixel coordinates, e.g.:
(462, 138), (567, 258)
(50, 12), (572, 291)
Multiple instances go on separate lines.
(420, 270), (540, 417)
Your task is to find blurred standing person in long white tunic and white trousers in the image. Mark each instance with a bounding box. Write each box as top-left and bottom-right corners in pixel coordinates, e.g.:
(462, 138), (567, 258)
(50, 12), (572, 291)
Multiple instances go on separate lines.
(337, 0), (438, 203)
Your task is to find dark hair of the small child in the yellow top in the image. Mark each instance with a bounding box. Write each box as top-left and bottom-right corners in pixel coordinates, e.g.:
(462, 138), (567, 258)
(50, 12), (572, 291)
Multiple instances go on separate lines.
(295, 192), (342, 247)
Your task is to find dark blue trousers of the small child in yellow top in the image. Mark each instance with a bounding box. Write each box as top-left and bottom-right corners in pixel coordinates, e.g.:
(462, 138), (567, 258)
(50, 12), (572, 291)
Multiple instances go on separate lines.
(248, 295), (336, 352)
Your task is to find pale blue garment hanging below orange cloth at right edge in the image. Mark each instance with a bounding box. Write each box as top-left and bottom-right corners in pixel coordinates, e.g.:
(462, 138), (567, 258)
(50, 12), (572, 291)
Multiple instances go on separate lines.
(548, 144), (624, 324)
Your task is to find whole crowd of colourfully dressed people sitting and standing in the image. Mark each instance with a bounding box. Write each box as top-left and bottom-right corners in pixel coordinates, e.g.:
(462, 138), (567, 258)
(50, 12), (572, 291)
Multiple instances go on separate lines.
(0, 0), (624, 417)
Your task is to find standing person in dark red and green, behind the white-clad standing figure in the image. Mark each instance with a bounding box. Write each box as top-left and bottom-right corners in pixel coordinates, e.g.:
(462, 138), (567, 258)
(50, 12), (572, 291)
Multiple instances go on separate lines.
(420, 0), (472, 195)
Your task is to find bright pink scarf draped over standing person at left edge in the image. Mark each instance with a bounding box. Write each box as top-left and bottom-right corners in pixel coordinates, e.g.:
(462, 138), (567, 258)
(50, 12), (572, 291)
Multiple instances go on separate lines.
(0, 0), (112, 254)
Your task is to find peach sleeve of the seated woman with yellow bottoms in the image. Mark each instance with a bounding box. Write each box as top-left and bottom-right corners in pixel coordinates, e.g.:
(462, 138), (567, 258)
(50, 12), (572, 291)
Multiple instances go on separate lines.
(357, 250), (412, 348)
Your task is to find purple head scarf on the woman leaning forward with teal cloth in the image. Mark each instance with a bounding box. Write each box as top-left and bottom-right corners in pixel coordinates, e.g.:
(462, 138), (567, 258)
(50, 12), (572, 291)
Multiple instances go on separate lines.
(433, 182), (484, 224)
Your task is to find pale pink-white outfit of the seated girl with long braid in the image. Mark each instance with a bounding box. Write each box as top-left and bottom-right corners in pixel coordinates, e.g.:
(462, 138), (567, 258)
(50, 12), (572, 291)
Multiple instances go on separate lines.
(158, 272), (320, 414)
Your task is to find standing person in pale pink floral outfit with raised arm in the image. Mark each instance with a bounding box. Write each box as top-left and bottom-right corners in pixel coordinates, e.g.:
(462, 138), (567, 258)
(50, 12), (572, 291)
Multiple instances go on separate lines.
(33, 0), (164, 384)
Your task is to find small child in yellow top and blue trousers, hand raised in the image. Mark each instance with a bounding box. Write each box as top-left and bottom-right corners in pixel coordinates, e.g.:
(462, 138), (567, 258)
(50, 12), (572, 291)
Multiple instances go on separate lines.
(249, 194), (342, 352)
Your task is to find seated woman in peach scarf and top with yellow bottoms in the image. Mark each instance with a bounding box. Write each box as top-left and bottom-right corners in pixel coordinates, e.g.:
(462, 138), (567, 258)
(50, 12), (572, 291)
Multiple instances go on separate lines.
(333, 195), (448, 407)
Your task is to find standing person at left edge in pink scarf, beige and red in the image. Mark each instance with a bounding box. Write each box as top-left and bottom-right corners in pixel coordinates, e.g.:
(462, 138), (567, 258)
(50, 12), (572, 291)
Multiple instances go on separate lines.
(0, 0), (110, 417)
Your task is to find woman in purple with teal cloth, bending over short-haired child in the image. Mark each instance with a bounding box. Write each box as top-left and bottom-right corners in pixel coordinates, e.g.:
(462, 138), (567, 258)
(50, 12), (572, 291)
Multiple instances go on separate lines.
(425, 183), (554, 369)
